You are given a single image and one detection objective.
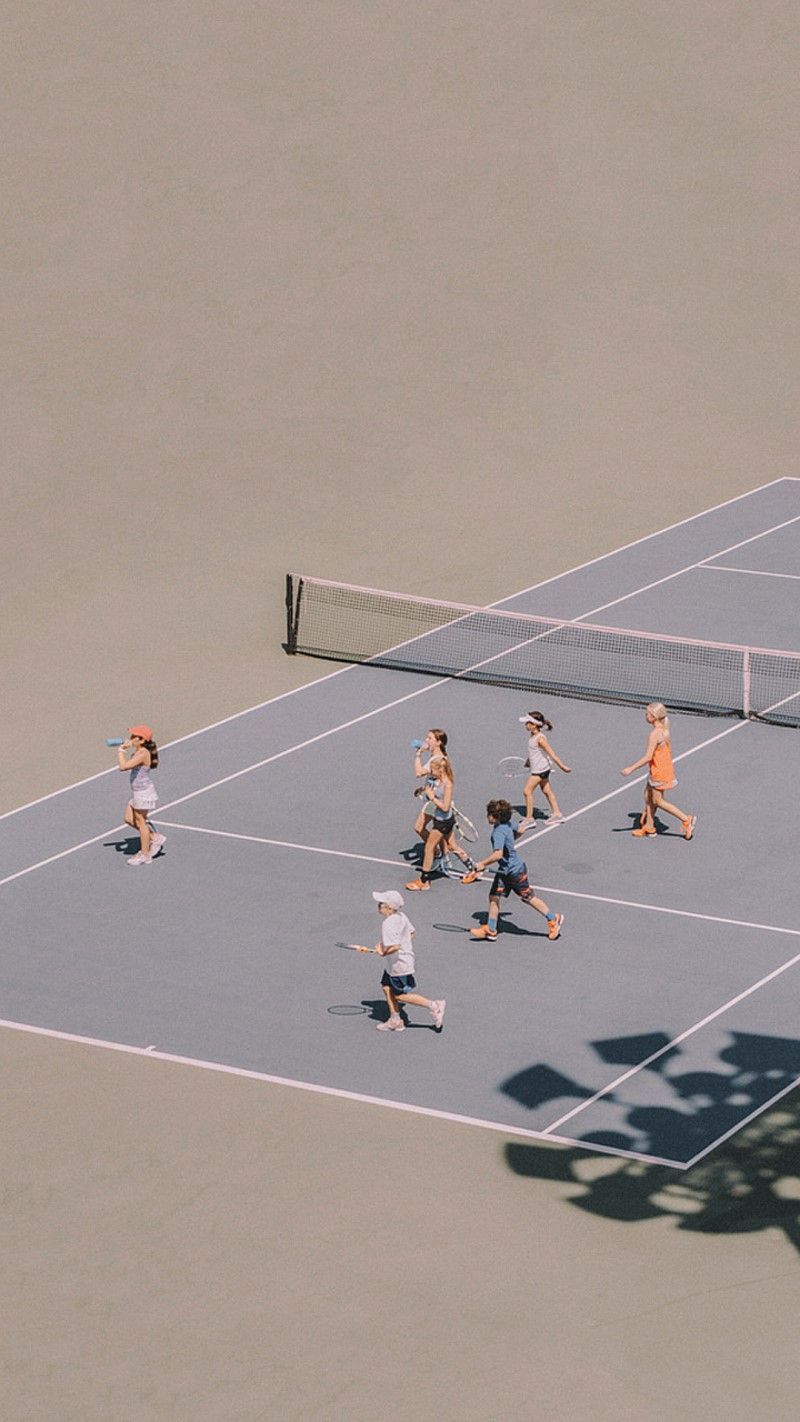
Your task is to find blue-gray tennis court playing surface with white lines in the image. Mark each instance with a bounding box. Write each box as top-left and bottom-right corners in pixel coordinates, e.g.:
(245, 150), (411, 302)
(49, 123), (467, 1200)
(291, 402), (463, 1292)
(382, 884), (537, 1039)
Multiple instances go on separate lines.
(0, 479), (800, 1167)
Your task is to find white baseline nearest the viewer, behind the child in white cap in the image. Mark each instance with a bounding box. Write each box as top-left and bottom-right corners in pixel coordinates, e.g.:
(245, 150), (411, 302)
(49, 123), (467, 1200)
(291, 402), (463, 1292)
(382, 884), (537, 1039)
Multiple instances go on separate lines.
(0, 1018), (685, 1170)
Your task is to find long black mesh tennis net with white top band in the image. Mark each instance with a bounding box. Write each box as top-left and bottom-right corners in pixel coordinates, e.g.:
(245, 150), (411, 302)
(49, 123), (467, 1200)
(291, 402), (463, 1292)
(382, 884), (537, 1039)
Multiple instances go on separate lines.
(283, 573), (800, 727)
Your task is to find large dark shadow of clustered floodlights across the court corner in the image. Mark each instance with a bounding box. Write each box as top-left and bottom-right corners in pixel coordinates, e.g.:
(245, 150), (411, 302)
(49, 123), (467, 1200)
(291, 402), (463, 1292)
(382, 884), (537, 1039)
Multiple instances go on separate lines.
(502, 1032), (800, 1253)
